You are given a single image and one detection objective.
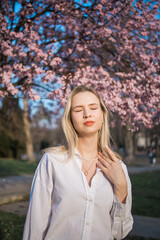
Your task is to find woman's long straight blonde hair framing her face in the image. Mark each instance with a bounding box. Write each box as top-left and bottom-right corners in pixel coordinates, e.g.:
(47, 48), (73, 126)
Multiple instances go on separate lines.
(62, 85), (110, 159)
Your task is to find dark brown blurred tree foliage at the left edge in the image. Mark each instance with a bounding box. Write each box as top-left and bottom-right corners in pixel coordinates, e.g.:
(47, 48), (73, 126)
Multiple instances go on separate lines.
(0, 97), (26, 159)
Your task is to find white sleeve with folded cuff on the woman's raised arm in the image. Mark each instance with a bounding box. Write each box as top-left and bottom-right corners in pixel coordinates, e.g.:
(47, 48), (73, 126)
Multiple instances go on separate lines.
(111, 163), (133, 240)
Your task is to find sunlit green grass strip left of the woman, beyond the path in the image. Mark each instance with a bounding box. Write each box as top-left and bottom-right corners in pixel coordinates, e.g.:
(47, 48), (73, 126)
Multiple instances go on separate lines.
(0, 159), (38, 177)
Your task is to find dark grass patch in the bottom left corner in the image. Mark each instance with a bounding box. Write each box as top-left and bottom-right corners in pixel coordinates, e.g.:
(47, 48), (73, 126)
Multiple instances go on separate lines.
(0, 211), (25, 240)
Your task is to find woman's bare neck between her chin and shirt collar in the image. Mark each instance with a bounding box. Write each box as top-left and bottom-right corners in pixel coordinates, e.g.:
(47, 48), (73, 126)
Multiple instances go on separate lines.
(78, 136), (98, 159)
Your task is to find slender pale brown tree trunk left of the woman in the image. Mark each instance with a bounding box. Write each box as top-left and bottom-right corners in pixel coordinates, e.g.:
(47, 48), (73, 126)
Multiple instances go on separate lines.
(23, 98), (35, 162)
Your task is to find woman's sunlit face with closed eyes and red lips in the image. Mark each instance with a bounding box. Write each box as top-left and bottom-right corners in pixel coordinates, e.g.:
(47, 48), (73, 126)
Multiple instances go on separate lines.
(71, 91), (103, 136)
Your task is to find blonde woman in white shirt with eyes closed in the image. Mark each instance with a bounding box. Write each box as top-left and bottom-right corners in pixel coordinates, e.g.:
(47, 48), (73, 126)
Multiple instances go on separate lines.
(23, 86), (133, 240)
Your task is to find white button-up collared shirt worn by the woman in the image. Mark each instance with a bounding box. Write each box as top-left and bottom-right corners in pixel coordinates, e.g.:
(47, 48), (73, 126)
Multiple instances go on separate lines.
(23, 151), (133, 240)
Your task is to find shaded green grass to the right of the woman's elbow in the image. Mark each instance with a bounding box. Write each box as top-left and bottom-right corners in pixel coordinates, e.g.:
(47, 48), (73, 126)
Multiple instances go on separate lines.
(130, 171), (160, 218)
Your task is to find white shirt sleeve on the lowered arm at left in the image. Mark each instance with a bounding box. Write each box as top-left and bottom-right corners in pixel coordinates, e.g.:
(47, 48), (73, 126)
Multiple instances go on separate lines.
(23, 153), (53, 240)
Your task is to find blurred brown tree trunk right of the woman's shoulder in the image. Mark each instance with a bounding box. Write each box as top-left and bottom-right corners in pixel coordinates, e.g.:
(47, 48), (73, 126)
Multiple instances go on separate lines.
(124, 127), (135, 164)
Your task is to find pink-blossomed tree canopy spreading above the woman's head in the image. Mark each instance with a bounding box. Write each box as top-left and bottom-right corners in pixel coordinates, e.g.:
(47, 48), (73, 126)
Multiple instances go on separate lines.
(0, 0), (160, 161)
